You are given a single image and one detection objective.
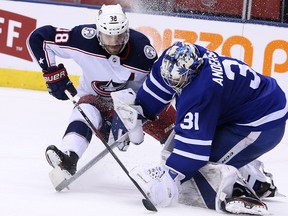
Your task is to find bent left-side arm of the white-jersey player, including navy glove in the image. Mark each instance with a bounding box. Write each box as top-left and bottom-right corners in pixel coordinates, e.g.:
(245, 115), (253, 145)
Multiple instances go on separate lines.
(27, 26), (77, 100)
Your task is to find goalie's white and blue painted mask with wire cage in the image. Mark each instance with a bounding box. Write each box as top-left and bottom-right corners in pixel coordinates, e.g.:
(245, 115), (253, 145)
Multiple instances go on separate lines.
(161, 42), (203, 94)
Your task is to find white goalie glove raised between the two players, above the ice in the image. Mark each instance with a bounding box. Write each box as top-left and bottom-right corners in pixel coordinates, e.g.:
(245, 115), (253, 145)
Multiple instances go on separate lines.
(111, 89), (144, 146)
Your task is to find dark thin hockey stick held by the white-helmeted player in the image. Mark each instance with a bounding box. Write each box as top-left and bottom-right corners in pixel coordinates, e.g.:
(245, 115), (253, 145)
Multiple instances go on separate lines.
(65, 90), (157, 212)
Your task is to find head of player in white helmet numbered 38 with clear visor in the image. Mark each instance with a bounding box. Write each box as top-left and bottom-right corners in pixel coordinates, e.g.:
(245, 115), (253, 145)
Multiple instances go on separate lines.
(96, 4), (129, 55)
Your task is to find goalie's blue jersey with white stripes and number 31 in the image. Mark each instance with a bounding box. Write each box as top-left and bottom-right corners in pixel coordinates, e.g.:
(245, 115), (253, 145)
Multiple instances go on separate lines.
(136, 43), (288, 177)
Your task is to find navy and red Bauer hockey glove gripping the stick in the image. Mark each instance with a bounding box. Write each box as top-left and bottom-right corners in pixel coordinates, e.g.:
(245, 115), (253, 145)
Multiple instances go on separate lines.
(43, 64), (77, 100)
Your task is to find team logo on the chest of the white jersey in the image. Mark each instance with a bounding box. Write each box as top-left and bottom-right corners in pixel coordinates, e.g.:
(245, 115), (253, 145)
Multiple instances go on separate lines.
(91, 80), (127, 97)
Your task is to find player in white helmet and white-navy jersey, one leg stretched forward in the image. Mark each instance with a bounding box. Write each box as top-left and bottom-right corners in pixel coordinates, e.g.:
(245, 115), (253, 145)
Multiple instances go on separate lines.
(28, 4), (175, 179)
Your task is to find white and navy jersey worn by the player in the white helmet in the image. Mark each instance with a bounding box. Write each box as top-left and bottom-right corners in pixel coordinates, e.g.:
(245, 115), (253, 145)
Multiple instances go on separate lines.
(28, 24), (157, 97)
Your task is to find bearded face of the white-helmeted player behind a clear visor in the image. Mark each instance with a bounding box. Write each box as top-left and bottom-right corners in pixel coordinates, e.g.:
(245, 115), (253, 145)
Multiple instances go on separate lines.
(99, 32), (129, 55)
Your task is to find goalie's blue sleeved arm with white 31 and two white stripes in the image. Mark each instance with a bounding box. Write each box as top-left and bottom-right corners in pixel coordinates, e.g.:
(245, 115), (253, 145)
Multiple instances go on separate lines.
(166, 90), (222, 181)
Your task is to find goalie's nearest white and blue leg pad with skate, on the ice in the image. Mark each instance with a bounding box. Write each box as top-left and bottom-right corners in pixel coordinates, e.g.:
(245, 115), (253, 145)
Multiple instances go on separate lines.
(179, 163), (268, 215)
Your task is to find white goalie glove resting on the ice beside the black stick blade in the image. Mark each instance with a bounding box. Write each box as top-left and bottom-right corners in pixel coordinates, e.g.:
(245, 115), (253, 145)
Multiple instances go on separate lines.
(129, 164), (179, 207)
